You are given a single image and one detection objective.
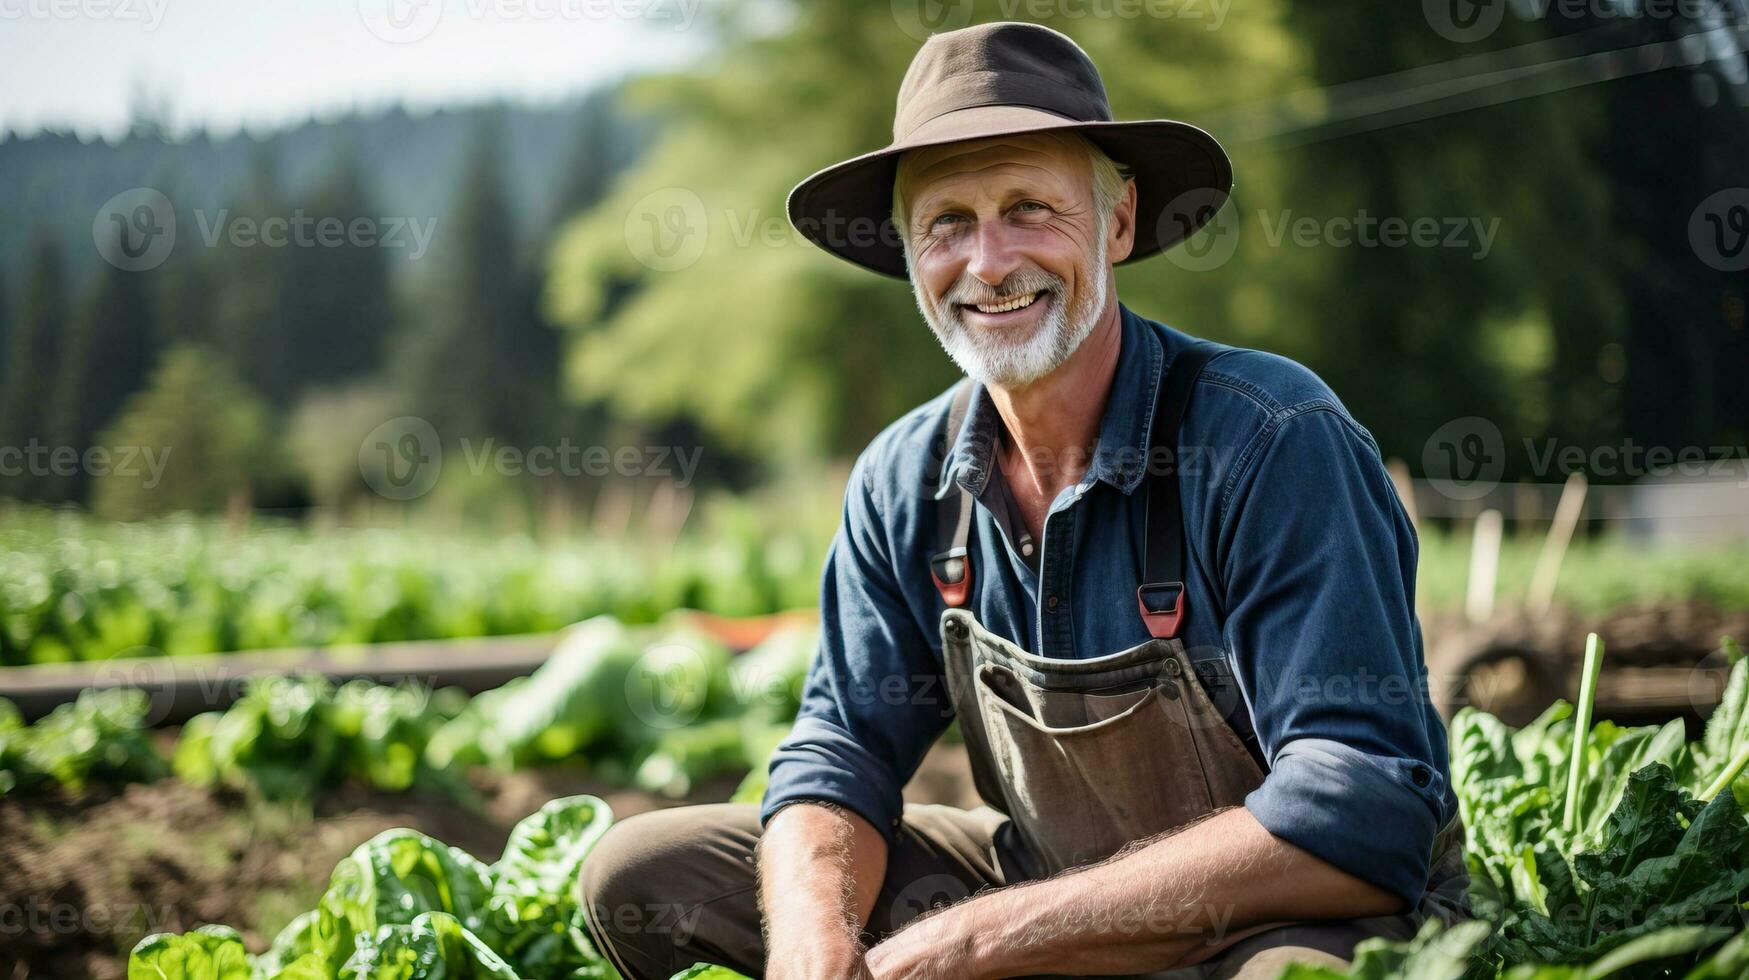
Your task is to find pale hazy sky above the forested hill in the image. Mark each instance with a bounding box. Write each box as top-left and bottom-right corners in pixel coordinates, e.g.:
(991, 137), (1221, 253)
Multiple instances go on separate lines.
(0, 0), (705, 135)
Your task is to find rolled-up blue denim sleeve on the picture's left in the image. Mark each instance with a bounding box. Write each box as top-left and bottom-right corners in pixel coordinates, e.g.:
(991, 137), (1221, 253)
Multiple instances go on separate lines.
(759, 455), (953, 842)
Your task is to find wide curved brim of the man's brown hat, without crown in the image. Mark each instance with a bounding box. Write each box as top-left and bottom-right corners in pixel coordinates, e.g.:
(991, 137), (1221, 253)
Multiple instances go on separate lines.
(785, 105), (1233, 278)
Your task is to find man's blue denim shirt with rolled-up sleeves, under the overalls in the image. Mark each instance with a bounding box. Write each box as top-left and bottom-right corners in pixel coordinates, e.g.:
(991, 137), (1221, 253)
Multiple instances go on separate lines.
(761, 306), (1457, 901)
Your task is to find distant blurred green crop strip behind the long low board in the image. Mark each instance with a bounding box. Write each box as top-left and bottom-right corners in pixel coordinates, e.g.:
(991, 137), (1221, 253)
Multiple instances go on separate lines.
(0, 508), (824, 665)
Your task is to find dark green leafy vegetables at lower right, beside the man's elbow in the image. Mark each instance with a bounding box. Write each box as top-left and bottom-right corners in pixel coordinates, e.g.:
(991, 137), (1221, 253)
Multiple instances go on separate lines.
(1284, 637), (1749, 980)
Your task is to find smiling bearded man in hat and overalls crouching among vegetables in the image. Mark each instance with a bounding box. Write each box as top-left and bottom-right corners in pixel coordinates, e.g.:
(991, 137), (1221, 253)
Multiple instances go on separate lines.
(581, 23), (1464, 978)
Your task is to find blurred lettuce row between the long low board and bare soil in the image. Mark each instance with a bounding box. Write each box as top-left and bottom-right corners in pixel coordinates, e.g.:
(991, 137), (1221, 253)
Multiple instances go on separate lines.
(0, 616), (815, 800)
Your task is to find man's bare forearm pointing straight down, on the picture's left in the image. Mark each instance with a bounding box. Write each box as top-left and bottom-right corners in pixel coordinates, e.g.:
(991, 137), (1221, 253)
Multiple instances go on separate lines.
(757, 803), (887, 980)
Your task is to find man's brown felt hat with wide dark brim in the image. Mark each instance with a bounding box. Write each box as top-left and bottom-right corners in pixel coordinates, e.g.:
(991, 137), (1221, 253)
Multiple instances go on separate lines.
(787, 21), (1233, 278)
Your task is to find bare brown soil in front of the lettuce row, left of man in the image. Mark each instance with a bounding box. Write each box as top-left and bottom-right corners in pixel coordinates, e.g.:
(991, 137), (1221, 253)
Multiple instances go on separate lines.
(0, 746), (976, 980)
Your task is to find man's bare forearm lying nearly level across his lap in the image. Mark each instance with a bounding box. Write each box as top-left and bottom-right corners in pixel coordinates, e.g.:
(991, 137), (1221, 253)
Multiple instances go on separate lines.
(869, 809), (1403, 978)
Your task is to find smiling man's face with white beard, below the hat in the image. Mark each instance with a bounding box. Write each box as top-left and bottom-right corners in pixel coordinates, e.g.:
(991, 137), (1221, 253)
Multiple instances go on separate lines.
(899, 133), (1133, 389)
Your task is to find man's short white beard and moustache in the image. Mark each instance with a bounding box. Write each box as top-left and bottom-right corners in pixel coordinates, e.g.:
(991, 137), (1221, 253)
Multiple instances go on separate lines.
(911, 229), (1107, 389)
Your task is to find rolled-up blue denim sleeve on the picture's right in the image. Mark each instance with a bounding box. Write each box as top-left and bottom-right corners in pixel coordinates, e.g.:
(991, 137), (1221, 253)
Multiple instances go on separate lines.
(1219, 406), (1455, 905)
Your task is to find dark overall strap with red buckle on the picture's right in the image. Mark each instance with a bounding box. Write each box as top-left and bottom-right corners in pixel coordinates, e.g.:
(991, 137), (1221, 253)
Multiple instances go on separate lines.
(1135, 341), (1221, 639)
